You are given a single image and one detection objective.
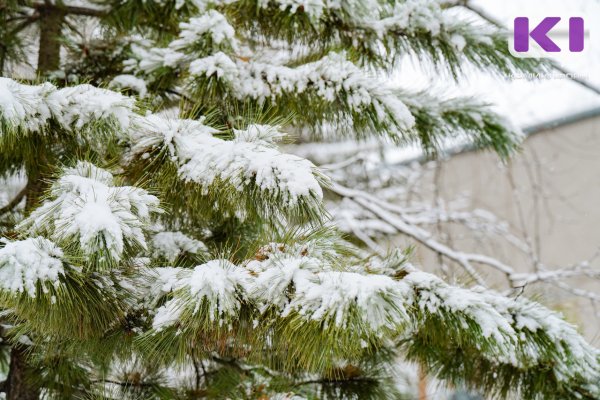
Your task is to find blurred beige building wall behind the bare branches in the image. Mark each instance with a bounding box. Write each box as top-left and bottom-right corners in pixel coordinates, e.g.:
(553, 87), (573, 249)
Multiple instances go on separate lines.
(410, 117), (600, 345)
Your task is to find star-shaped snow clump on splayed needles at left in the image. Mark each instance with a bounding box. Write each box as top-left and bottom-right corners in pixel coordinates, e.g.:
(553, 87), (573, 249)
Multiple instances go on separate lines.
(19, 161), (160, 261)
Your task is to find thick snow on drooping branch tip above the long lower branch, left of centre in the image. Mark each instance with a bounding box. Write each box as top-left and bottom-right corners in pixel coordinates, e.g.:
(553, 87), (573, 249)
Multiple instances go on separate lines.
(132, 115), (323, 205)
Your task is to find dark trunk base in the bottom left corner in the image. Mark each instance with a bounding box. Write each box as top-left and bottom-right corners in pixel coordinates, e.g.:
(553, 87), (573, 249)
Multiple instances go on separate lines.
(5, 345), (40, 400)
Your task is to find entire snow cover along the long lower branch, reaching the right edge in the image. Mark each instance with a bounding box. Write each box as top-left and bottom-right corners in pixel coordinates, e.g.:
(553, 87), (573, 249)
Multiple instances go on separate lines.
(146, 251), (600, 382)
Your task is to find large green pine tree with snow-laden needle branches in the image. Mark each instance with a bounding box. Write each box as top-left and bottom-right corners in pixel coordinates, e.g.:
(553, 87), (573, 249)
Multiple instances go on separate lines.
(0, 0), (600, 400)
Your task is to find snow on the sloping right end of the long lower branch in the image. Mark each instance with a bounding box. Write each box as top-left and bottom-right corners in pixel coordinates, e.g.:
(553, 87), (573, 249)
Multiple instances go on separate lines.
(403, 271), (600, 381)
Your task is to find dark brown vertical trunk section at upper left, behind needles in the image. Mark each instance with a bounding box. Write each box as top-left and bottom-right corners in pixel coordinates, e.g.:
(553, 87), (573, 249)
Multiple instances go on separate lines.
(38, 2), (65, 74)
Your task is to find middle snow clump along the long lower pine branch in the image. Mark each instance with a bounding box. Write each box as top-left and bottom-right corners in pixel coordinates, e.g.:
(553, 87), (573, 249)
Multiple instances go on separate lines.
(247, 253), (410, 332)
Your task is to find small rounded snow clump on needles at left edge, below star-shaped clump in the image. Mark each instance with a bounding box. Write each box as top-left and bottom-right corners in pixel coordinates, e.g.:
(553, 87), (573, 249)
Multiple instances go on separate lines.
(0, 237), (65, 297)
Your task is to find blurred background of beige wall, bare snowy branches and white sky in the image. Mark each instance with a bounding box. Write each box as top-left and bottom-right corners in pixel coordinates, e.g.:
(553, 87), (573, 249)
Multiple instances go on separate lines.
(293, 0), (600, 352)
